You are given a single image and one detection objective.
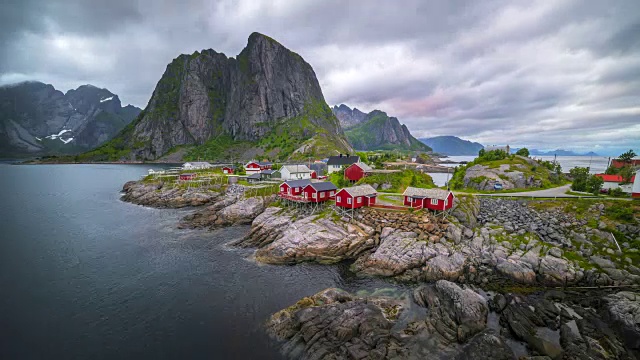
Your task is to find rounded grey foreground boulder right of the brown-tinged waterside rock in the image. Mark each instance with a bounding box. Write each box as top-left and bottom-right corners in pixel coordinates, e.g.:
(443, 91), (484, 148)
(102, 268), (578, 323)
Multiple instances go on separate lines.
(413, 280), (489, 342)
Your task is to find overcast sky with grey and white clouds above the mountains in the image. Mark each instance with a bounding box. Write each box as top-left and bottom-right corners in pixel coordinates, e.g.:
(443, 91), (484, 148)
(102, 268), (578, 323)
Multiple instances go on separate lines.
(0, 0), (640, 155)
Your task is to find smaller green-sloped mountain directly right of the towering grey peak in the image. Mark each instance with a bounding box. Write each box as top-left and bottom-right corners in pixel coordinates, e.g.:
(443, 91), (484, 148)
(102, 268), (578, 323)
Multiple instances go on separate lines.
(333, 105), (431, 151)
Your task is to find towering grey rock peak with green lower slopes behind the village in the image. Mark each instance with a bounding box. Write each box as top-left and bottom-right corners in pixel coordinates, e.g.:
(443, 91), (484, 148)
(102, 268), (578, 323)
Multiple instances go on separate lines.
(97, 33), (350, 160)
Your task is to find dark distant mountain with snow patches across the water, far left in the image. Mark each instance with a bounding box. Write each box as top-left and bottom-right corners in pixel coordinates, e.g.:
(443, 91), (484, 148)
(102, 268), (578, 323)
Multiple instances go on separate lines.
(0, 82), (140, 157)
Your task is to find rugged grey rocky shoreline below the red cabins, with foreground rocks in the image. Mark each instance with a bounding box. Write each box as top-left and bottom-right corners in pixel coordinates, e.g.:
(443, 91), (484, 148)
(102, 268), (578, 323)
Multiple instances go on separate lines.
(117, 182), (640, 359)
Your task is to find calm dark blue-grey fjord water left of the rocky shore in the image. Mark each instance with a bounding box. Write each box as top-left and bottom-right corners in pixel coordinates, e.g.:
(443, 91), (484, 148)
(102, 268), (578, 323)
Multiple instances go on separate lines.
(0, 164), (384, 359)
